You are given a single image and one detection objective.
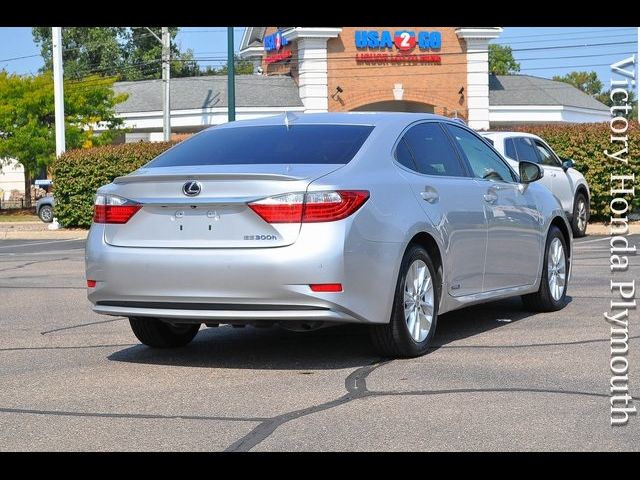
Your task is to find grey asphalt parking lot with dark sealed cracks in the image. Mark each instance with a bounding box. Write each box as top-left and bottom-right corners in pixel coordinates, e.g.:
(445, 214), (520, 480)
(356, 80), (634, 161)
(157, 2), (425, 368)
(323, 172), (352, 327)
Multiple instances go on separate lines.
(0, 235), (640, 451)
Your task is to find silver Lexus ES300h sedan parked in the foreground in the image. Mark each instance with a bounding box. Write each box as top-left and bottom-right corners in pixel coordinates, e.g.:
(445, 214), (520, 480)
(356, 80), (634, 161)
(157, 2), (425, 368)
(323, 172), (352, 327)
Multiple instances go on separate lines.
(86, 112), (572, 357)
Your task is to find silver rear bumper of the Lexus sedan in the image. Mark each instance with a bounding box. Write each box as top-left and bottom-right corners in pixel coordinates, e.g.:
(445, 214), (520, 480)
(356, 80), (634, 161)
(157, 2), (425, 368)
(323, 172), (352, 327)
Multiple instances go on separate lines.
(86, 222), (402, 323)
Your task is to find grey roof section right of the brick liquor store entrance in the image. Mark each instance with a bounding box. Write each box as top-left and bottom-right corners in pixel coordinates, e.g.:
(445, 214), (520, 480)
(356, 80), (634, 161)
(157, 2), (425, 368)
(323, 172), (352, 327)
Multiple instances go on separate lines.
(489, 75), (609, 111)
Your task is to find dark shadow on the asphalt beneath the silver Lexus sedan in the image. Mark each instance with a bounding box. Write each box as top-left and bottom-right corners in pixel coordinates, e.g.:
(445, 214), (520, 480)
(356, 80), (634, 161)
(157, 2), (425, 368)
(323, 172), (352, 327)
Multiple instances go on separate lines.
(108, 297), (571, 370)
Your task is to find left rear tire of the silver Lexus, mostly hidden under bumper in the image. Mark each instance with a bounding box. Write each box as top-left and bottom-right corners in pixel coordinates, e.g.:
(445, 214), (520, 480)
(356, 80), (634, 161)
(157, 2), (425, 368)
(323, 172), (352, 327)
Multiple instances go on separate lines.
(129, 317), (200, 348)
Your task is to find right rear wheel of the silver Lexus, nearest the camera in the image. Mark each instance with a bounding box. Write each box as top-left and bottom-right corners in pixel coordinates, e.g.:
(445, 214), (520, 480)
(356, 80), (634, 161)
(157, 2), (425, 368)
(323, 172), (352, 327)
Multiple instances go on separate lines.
(370, 245), (440, 358)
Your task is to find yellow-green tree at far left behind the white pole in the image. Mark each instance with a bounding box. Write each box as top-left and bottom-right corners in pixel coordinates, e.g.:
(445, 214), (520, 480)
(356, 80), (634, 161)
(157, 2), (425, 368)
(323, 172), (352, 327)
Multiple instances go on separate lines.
(0, 71), (127, 206)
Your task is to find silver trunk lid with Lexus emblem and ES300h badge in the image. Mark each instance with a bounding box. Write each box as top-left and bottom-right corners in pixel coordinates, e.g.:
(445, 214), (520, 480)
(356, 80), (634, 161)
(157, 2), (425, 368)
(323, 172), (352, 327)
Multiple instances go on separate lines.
(104, 164), (343, 248)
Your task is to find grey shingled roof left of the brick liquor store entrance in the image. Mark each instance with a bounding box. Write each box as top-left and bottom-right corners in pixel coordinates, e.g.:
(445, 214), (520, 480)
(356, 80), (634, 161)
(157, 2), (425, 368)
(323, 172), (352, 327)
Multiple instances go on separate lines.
(113, 75), (303, 113)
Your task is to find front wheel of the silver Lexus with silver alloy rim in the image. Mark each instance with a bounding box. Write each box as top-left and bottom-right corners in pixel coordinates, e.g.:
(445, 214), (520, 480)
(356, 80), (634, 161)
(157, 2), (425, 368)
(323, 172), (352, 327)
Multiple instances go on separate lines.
(522, 225), (569, 312)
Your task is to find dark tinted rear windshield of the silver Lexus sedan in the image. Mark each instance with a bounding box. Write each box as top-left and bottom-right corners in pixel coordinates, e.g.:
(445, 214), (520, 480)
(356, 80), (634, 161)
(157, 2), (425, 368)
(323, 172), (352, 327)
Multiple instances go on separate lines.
(145, 125), (373, 168)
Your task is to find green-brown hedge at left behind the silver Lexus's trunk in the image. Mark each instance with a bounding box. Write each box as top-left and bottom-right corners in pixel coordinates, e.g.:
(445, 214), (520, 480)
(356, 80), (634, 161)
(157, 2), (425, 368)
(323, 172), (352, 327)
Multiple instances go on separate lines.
(51, 142), (176, 227)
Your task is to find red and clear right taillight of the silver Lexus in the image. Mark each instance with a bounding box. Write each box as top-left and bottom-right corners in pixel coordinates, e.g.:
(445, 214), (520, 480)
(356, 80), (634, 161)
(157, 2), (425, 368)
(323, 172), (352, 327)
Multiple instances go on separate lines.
(249, 190), (369, 223)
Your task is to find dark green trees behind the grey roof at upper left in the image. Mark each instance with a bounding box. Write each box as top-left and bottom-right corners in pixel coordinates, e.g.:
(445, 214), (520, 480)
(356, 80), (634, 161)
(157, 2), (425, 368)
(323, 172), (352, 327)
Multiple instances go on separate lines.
(32, 27), (198, 80)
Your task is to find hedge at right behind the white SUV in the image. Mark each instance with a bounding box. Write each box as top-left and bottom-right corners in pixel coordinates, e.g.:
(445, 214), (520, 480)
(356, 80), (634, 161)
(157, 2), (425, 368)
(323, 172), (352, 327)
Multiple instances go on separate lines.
(498, 122), (640, 220)
